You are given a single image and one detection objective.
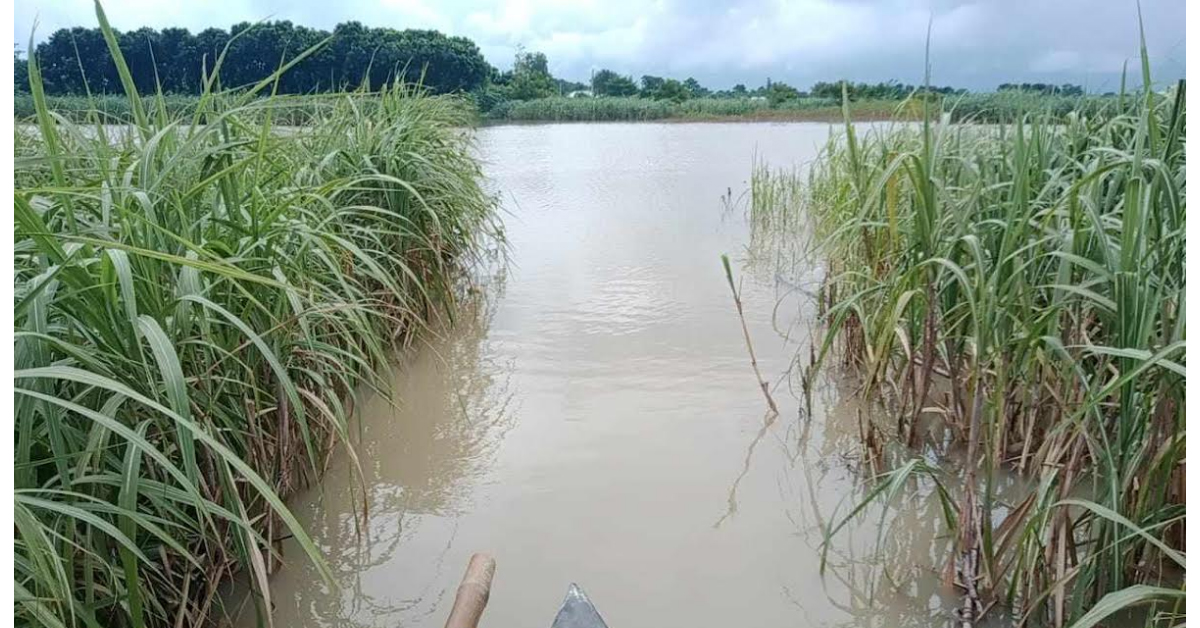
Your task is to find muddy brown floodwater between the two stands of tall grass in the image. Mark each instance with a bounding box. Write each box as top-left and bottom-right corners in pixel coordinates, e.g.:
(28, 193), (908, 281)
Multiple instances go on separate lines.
(243, 124), (984, 628)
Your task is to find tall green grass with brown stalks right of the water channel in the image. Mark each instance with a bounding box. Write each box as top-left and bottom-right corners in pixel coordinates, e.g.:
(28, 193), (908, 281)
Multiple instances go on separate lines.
(782, 46), (1187, 626)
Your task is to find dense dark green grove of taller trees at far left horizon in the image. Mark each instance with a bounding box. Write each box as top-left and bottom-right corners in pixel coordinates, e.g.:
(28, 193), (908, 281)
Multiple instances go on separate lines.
(17, 22), (492, 95)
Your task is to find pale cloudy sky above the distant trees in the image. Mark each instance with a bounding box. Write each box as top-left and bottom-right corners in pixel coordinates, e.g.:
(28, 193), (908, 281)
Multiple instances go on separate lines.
(14, 0), (1184, 91)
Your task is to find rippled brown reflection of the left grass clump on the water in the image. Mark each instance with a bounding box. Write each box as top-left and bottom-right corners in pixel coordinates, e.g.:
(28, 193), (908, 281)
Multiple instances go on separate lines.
(250, 289), (516, 626)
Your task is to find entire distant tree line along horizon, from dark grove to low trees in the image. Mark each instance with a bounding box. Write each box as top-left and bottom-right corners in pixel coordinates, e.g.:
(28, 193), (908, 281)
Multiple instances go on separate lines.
(16, 20), (1099, 105)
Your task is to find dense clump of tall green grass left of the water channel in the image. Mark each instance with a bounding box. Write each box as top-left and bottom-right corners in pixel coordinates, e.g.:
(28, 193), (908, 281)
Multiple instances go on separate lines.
(14, 4), (498, 627)
